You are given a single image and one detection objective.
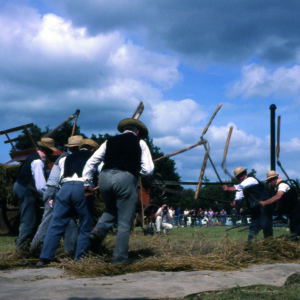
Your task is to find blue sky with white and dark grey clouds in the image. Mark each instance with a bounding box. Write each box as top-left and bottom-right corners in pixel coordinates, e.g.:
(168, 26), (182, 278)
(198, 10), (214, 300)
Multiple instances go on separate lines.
(0, 0), (300, 185)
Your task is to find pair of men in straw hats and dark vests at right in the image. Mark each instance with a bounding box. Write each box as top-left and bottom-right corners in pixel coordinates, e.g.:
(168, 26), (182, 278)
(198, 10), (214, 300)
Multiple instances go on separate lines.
(223, 167), (300, 242)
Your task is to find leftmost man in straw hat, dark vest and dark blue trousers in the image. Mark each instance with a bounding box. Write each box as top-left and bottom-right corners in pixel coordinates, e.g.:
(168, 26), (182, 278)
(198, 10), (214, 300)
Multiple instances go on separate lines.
(13, 137), (57, 250)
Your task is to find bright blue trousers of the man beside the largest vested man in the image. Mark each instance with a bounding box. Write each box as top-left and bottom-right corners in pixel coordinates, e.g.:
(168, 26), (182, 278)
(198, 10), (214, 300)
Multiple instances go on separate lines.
(40, 181), (94, 260)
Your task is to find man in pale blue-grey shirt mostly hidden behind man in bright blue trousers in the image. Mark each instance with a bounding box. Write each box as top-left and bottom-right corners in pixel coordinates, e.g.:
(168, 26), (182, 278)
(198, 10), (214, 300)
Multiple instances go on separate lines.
(30, 135), (83, 253)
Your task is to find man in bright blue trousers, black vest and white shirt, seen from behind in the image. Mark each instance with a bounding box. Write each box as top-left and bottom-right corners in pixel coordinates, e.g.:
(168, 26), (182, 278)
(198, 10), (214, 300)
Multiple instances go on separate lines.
(36, 139), (99, 267)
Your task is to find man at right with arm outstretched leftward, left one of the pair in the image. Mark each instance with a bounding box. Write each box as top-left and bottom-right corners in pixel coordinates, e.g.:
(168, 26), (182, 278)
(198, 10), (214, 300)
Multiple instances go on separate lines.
(223, 167), (273, 242)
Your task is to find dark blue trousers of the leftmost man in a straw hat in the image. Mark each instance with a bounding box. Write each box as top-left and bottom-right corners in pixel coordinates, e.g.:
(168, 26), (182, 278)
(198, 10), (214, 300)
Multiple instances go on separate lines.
(13, 182), (42, 247)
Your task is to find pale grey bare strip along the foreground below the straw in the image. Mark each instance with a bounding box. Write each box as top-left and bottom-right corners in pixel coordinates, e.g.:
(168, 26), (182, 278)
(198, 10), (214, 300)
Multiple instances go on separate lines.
(0, 264), (300, 300)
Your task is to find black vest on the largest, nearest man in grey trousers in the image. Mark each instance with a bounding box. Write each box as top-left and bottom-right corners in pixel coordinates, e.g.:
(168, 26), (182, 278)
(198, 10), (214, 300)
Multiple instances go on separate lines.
(103, 133), (142, 177)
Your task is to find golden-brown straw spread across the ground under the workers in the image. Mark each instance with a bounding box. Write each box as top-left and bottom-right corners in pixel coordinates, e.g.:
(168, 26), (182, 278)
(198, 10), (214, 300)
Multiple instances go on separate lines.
(0, 232), (300, 277)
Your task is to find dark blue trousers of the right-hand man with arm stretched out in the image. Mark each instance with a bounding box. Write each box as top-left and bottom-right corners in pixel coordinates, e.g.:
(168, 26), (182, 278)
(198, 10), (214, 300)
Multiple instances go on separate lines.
(248, 206), (273, 242)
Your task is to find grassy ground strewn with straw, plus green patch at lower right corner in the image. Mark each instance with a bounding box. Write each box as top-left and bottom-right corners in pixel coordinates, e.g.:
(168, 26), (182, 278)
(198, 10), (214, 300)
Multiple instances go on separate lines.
(0, 227), (300, 299)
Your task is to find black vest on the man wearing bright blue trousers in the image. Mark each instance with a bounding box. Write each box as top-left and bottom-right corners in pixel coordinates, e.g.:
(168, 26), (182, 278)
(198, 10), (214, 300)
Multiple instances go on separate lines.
(63, 150), (93, 178)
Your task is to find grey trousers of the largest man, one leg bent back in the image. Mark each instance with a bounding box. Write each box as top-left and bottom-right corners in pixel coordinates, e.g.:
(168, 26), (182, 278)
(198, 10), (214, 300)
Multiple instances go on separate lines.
(95, 169), (138, 263)
